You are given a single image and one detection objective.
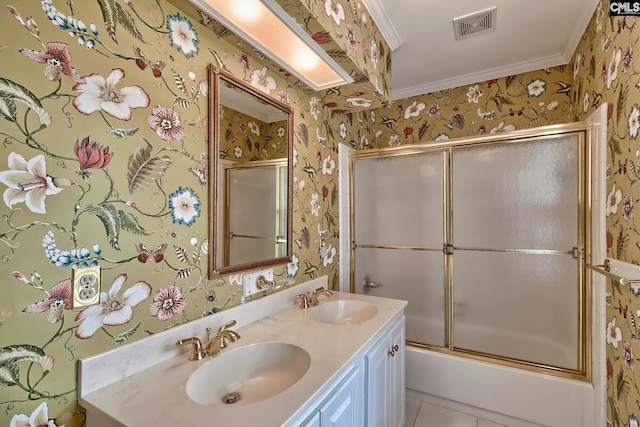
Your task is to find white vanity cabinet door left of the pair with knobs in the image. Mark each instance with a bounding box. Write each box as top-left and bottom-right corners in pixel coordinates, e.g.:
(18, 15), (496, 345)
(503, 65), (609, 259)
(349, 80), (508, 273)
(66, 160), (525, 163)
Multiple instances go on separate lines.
(320, 364), (364, 427)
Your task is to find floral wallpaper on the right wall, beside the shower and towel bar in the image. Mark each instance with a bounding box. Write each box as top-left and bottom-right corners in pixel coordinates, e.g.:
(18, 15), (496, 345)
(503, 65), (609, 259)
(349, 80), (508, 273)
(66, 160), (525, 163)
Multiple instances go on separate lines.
(571, 1), (640, 426)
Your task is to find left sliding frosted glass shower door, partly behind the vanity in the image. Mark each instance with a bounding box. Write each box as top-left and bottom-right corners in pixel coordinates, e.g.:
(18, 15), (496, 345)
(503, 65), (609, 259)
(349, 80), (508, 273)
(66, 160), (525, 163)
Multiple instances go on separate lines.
(353, 151), (445, 346)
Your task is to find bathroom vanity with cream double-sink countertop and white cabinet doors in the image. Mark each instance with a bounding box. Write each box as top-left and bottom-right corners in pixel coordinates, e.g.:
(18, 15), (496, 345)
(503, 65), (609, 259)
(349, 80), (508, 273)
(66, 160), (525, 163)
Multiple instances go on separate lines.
(79, 277), (407, 427)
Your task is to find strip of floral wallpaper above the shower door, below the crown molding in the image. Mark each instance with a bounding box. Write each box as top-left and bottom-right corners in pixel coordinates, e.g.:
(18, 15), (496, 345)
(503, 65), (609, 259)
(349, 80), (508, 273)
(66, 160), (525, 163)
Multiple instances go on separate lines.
(331, 66), (574, 149)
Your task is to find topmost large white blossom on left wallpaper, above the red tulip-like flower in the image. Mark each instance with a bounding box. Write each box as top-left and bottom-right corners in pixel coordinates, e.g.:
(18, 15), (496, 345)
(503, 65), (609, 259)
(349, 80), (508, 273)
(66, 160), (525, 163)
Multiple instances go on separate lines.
(73, 68), (149, 120)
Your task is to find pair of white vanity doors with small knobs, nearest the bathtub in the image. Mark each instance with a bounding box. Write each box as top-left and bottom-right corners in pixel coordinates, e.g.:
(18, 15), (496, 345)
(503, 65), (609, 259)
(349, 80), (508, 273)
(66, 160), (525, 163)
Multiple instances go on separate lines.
(365, 316), (405, 427)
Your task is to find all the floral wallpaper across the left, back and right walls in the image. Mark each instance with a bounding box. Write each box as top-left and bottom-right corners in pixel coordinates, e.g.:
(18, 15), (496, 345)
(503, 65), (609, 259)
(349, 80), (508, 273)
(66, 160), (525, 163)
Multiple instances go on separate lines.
(0, 0), (640, 426)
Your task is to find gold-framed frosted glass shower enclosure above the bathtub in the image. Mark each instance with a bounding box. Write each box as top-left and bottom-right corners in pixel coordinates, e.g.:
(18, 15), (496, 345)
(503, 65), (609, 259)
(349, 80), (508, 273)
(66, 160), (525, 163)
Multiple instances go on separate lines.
(350, 125), (590, 380)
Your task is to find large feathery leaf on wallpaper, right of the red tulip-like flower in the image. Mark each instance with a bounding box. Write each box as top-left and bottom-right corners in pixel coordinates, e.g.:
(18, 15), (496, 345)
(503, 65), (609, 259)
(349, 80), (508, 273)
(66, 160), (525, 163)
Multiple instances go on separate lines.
(127, 138), (172, 194)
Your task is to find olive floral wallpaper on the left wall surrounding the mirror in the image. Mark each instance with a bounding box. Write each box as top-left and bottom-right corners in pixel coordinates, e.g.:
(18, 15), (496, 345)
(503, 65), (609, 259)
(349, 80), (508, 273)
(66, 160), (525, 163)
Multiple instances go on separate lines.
(0, 0), (338, 426)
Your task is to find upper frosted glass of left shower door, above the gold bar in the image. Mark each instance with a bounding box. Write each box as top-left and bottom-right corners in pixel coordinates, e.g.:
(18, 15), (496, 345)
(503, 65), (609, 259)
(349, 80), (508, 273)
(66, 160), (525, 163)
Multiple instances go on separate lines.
(354, 152), (443, 248)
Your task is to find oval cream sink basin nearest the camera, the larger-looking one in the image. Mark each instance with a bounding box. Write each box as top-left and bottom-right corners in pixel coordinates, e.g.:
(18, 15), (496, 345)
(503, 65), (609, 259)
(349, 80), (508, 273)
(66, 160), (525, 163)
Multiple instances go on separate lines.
(186, 342), (311, 407)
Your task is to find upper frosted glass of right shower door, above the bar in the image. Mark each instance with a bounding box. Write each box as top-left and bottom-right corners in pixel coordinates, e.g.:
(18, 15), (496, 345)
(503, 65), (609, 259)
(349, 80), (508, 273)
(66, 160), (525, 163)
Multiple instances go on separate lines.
(453, 135), (578, 251)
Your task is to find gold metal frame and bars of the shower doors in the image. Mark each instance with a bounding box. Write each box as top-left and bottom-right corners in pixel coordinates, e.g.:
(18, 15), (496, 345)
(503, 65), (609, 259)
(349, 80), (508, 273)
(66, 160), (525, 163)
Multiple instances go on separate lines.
(349, 122), (592, 381)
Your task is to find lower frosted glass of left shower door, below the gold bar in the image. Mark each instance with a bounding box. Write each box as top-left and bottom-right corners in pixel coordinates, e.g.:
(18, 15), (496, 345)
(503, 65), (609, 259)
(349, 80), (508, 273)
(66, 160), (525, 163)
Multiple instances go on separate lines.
(355, 248), (445, 346)
